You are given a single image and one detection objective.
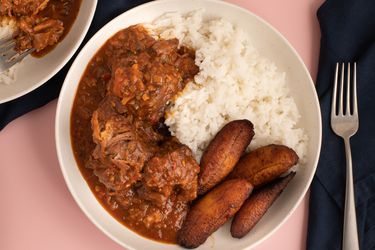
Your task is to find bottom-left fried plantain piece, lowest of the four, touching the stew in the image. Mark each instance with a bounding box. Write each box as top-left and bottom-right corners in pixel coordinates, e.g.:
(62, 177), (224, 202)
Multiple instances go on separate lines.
(177, 179), (253, 248)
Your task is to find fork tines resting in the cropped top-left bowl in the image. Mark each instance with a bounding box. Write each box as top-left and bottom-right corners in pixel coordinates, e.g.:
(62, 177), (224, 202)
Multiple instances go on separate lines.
(0, 36), (34, 74)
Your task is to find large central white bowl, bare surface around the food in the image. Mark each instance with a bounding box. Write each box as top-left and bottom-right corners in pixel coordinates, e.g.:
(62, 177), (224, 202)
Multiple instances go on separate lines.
(56, 0), (321, 250)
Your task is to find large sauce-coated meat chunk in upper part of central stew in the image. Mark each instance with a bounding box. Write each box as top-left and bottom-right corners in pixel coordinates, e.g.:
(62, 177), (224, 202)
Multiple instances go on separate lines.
(111, 62), (182, 124)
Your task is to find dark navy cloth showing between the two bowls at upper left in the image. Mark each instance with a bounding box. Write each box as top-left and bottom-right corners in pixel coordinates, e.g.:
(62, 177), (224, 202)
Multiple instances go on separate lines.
(0, 0), (150, 130)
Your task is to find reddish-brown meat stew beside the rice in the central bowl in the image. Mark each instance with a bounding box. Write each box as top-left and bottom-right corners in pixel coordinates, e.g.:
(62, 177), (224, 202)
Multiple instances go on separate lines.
(71, 26), (199, 243)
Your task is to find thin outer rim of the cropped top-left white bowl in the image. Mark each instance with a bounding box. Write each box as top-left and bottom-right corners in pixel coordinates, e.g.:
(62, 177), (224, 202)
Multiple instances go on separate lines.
(0, 0), (98, 104)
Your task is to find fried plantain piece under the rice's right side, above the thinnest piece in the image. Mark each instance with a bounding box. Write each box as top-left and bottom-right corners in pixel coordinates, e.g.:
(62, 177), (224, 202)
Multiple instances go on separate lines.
(228, 144), (298, 188)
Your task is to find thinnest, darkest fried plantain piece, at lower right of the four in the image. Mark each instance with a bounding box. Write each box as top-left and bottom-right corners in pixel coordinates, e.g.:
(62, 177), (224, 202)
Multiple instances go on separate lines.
(230, 172), (296, 238)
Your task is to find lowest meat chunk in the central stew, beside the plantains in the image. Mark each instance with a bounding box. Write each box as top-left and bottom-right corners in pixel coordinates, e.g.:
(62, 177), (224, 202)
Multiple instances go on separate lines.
(142, 140), (199, 204)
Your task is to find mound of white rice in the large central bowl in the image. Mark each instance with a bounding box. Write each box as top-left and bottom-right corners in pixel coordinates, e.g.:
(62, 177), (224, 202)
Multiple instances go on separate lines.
(152, 10), (308, 163)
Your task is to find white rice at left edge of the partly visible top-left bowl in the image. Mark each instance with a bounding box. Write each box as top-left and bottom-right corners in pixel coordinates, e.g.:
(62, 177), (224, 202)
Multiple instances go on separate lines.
(0, 17), (19, 84)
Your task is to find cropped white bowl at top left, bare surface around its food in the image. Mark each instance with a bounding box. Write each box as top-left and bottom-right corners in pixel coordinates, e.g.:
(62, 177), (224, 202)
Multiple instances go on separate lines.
(0, 0), (98, 103)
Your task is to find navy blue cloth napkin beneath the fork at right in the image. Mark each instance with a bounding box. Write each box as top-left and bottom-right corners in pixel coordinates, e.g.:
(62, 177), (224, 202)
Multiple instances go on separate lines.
(307, 0), (375, 250)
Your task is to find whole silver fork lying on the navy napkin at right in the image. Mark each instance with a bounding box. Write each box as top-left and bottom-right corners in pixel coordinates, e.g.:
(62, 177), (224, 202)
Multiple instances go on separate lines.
(331, 63), (359, 250)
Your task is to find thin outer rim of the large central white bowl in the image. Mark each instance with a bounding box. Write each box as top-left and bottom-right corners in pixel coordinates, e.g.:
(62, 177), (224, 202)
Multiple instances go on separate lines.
(55, 0), (322, 249)
